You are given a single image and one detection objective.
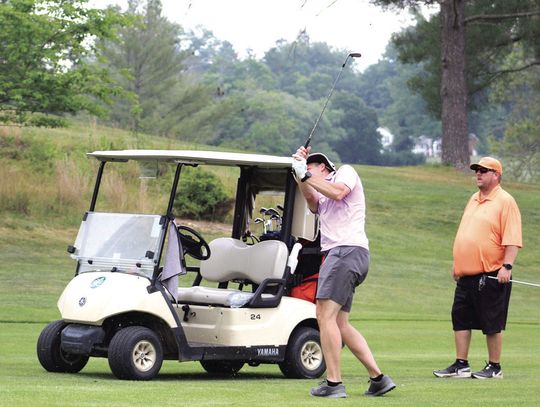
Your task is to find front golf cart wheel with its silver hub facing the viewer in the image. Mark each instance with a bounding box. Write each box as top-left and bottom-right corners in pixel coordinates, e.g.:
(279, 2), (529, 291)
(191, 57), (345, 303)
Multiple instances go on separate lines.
(108, 326), (163, 380)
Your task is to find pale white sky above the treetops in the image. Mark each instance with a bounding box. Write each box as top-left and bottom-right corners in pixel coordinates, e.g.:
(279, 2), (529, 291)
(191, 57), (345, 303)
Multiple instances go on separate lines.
(90, 0), (424, 70)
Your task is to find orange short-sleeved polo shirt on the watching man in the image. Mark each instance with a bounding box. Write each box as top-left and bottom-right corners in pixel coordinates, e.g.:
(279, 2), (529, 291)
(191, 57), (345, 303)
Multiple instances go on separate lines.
(454, 185), (522, 277)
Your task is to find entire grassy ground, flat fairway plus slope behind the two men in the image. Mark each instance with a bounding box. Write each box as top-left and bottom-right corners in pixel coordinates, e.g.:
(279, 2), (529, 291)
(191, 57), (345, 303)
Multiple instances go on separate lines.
(0, 166), (540, 406)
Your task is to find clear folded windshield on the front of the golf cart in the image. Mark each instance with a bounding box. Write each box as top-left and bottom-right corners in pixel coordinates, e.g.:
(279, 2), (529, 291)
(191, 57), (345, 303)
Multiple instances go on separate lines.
(71, 212), (164, 278)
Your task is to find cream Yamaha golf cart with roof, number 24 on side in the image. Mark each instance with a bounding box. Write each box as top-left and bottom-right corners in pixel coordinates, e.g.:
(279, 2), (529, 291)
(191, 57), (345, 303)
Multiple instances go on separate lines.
(37, 150), (326, 380)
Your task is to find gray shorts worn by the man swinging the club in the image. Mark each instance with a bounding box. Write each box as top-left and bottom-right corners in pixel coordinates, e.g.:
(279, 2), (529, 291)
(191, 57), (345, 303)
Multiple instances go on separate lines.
(317, 246), (369, 312)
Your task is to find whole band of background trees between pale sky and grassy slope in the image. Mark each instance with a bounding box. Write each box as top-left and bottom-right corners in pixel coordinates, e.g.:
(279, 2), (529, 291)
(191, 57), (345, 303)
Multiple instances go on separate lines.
(0, 0), (540, 178)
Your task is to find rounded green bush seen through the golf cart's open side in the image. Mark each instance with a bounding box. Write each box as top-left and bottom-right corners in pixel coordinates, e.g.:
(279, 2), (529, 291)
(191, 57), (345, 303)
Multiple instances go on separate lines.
(174, 168), (234, 221)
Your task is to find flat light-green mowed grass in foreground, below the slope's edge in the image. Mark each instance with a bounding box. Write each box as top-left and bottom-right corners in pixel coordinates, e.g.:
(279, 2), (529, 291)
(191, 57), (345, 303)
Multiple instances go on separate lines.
(0, 322), (540, 406)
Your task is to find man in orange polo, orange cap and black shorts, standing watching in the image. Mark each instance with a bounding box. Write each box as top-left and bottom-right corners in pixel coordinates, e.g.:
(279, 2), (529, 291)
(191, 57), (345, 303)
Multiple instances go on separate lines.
(433, 157), (522, 379)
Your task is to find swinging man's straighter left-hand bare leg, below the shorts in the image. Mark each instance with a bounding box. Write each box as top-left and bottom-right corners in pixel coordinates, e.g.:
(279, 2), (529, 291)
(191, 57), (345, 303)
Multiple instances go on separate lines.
(317, 299), (341, 382)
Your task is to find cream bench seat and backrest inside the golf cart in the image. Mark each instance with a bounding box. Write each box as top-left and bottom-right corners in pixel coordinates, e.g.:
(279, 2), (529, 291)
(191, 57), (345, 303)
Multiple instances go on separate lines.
(177, 237), (288, 308)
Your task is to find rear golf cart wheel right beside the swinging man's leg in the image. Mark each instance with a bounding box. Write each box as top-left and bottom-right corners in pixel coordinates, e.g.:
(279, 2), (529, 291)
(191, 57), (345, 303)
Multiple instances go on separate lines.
(279, 326), (326, 379)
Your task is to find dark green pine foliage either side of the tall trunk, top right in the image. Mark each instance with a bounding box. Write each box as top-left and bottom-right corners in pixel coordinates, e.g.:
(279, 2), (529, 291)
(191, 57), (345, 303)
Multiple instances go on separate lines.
(388, 0), (540, 117)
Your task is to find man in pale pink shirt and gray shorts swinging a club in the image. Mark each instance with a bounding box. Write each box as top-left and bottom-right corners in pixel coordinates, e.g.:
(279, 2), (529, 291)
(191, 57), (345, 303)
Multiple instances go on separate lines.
(292, 147), (396, 398)
